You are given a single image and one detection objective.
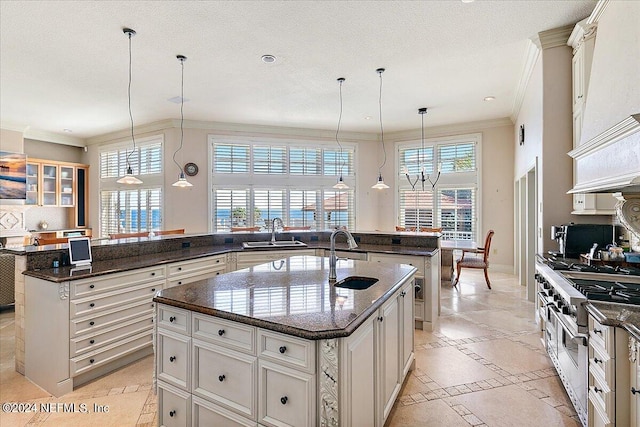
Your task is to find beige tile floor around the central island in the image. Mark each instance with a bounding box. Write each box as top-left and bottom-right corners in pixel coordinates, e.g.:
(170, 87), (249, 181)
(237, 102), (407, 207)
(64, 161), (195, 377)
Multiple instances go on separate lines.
(0, 270), (580, 427)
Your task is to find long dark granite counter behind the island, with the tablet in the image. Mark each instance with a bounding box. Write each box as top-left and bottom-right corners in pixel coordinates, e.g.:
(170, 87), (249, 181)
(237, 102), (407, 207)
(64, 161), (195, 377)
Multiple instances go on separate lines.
(23, 241), (438, 283)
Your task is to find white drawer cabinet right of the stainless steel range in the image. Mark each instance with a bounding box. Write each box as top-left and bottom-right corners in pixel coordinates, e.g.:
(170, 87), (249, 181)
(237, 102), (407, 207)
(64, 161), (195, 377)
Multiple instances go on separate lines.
(588, 316), (629, 427)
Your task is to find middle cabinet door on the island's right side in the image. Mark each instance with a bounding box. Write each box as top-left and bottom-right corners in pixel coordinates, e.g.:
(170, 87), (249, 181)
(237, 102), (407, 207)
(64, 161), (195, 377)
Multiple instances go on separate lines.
(378, 297), (402, 425)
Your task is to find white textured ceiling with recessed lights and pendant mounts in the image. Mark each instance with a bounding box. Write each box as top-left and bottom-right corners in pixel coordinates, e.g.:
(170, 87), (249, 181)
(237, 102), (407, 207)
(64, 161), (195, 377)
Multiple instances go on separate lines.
(0, 0), (596, 139)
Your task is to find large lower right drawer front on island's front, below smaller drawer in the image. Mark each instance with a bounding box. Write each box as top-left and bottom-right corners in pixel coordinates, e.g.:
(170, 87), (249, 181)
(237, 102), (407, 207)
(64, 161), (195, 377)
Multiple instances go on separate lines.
(258, 361), (316, 427)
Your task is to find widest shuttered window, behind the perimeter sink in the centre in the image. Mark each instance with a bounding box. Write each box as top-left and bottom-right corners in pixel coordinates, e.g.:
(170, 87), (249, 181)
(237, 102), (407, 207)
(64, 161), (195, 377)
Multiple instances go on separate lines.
(210, 137), (355, 231)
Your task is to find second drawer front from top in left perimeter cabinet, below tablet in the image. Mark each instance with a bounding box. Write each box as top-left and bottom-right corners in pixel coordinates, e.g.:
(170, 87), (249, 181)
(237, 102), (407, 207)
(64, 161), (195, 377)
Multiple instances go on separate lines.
(69, 282), (164, 319)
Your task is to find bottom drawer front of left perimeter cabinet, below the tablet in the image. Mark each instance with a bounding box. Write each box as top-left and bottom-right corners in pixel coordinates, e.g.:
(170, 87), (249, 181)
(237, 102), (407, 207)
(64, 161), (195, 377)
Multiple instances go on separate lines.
(69, 330), (153, 377)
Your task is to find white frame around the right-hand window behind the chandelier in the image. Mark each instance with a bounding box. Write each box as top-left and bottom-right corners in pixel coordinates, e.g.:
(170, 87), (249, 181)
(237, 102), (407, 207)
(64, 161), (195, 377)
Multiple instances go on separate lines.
(394, 132), (484, 244)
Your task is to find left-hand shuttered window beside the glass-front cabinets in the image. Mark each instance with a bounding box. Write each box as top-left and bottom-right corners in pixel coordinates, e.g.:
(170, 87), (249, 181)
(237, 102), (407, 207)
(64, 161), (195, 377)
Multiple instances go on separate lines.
(99, 136), (163, 237)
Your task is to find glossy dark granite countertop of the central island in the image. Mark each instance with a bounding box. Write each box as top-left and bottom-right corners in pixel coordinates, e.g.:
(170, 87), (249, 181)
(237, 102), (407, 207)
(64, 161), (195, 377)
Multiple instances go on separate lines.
(153, 256), (417, 340)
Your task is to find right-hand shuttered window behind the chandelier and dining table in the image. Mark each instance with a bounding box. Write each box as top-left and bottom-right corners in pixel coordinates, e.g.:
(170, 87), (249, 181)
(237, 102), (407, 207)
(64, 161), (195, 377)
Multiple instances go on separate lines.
(398, 134), (481, 241)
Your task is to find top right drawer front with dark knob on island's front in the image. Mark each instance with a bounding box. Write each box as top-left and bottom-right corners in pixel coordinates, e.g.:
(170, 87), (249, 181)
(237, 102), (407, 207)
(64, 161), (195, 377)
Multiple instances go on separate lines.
(258, 329), (316, 374)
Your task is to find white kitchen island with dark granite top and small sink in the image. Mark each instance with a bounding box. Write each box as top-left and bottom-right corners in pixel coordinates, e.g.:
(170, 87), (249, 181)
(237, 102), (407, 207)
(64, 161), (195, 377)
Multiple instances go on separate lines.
(154, 256), (417, 426)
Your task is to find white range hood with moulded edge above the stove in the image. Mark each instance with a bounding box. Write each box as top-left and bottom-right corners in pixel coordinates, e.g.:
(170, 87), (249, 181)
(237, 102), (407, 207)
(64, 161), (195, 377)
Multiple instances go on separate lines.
(569, 113), (640, 193)
